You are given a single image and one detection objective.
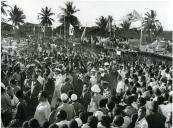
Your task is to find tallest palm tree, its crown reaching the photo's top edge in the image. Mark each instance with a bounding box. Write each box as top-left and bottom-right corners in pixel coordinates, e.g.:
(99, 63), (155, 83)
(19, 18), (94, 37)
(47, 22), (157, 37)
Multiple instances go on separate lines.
(59, 1), (80, 35)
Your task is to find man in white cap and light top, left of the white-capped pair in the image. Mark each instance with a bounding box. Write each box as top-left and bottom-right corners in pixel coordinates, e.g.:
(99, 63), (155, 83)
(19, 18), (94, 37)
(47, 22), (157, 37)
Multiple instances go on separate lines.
(57, 93), (75, 121)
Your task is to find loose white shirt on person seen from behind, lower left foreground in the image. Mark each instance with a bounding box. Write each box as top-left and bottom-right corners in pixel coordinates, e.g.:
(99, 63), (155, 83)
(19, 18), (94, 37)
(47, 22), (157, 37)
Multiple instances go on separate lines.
(34, 101), (51, 127)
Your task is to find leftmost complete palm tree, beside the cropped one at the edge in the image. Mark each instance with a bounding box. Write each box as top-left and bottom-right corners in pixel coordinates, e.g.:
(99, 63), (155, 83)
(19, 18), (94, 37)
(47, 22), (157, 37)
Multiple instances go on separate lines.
(9, 5), (26, 27)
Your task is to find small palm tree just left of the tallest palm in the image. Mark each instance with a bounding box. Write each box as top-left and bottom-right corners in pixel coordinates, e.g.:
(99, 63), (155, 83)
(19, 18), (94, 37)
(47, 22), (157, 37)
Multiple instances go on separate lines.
(38, 7), (55, 27)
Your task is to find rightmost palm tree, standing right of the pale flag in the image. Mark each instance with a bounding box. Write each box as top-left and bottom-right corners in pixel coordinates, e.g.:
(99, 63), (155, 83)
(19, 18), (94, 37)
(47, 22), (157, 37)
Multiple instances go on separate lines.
(142, 10), (163, 43)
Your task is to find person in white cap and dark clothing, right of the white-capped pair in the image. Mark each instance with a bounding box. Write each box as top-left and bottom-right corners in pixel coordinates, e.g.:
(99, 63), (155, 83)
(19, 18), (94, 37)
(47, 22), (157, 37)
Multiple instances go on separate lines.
(71, 94), (84, 116)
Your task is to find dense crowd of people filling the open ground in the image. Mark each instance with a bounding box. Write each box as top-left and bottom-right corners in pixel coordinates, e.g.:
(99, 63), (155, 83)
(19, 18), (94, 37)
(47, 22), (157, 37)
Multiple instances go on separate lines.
(1, 38), (173, 128)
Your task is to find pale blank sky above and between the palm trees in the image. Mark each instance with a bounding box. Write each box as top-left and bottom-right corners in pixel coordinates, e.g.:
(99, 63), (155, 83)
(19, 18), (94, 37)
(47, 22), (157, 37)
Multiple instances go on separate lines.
(4, 0), (173, 30)
